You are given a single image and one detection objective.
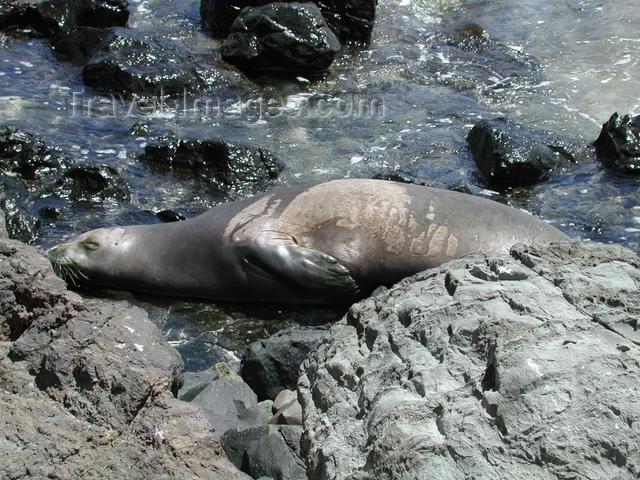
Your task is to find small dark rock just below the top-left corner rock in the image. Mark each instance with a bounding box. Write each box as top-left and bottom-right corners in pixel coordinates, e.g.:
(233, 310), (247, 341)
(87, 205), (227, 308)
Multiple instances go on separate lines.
(51, 27), (112, 65)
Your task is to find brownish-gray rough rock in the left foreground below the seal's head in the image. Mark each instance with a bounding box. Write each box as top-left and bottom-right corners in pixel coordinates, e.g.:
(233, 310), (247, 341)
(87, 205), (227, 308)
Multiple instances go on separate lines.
(0, 240), (247, 480)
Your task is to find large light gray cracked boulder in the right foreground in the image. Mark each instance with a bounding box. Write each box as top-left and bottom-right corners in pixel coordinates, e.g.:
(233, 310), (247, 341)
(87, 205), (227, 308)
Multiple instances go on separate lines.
(298, 243), (640, 480)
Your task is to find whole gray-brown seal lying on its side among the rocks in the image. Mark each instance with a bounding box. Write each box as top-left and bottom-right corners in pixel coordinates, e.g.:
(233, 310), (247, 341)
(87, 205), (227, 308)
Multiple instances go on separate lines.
(49, 179), (568, 303)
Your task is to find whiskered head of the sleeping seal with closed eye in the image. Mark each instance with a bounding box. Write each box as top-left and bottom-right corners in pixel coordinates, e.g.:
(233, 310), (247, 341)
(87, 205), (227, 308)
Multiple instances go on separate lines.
(47, 227), (135, 286)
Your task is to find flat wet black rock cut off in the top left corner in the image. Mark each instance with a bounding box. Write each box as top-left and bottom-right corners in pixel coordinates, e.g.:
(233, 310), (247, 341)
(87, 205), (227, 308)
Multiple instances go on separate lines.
(0, 0), (129, 38)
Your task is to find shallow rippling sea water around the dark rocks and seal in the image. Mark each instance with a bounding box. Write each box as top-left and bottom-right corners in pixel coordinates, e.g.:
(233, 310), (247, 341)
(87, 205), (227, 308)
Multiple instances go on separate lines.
(0, 0), (640, 370)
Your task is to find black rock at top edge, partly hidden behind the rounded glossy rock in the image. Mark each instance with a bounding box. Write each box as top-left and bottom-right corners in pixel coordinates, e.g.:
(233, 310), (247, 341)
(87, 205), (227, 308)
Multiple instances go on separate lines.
(200, 0), (378, 43)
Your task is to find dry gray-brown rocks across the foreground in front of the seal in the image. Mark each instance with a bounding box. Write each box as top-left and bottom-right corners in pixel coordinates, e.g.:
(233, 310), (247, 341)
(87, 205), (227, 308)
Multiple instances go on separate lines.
(0, 212), (640, 480)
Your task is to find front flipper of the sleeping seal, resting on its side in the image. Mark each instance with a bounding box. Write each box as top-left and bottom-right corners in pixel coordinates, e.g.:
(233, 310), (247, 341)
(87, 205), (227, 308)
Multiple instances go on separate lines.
(245, 242), (359, 297)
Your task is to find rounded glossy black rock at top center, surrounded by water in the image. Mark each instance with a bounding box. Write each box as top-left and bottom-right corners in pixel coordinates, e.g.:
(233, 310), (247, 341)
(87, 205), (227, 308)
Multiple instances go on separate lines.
(221, 3), (340, 74)
